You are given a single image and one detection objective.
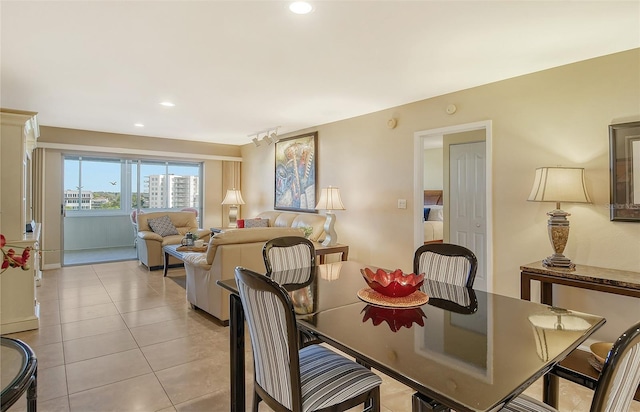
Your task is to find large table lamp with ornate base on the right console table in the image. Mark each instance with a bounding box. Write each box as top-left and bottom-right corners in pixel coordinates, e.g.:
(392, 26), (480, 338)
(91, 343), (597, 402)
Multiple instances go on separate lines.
(527, 167), (591, 269)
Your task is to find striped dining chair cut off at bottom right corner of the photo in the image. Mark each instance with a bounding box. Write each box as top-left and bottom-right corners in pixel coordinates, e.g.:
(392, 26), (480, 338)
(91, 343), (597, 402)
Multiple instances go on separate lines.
(502, 322), (640, 412)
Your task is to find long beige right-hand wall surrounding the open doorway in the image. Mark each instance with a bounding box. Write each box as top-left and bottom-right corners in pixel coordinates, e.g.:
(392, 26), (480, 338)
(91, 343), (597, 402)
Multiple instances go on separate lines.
(242, 49), (640, 339)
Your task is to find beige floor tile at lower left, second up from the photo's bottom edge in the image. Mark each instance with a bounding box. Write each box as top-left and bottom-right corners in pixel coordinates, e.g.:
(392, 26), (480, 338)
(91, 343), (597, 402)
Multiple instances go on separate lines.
(66, 348), (151, 395)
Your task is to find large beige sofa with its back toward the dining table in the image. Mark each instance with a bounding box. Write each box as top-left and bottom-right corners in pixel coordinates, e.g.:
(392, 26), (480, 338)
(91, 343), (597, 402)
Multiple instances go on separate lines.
(183, 227), (304, 323)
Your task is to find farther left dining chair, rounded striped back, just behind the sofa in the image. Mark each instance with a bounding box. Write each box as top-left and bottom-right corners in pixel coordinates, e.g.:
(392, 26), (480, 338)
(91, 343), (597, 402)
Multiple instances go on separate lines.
(262, 236), (320, 346)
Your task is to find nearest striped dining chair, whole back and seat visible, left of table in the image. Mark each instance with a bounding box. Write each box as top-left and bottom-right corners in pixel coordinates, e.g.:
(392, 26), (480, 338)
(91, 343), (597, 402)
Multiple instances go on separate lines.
(235, 267), (382, 412)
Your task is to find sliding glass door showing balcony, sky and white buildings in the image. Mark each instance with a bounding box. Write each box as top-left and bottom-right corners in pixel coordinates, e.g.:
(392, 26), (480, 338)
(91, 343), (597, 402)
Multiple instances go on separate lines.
(62, 155), (202, 265)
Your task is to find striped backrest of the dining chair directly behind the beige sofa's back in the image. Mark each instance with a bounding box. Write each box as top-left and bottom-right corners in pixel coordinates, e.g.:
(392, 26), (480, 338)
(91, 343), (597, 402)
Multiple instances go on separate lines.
(262, 236), (316, 275)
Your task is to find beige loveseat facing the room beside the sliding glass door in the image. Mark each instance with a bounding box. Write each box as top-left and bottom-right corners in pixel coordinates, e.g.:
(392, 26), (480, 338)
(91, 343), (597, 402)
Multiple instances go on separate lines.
(136, 212), (211, 270)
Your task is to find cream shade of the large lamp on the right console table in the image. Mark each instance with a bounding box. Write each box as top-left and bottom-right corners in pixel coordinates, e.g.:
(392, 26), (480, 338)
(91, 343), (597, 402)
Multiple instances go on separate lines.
(527, 167), (591, 203)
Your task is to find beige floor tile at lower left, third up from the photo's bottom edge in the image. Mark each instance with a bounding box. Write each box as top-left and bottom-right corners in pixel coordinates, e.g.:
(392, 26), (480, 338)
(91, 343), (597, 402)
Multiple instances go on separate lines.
(63, 329), (138, 364)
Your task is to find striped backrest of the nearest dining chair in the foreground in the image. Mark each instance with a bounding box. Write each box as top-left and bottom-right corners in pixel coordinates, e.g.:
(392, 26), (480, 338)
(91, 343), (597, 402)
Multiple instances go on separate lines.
(235, 267), (302, 411)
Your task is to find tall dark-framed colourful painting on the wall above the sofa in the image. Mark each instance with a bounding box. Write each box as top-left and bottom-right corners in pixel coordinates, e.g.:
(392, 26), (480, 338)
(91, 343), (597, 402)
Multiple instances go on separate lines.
(274, 132), (318, 213)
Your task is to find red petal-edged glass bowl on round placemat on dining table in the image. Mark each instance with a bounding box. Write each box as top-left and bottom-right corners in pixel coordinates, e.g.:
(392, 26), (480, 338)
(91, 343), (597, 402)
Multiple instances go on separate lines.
(358, 268), (429, 308)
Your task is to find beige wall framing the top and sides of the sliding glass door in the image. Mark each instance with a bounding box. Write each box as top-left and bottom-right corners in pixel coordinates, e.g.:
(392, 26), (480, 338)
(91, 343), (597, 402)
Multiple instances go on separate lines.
(38, 126), (241, 269)
